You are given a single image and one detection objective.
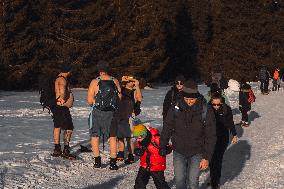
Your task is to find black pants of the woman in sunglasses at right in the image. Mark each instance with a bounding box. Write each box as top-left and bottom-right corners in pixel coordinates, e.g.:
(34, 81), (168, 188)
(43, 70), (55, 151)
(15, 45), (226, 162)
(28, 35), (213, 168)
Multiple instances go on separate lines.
(209, 134), (229, 186)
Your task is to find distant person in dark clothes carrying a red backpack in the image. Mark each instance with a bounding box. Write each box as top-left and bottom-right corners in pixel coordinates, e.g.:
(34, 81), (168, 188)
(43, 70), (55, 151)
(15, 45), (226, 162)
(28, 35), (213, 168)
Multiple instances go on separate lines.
(239, 82), (255, 127)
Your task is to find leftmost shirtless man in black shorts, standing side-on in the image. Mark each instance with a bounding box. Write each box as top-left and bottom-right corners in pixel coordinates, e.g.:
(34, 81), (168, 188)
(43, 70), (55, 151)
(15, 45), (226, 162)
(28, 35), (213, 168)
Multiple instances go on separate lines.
(51, 65), (75, 160)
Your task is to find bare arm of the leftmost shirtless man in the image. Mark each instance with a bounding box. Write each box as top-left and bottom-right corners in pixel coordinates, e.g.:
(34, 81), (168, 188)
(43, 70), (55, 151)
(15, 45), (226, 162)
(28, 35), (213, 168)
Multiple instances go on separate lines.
(55, 77), (67, 106)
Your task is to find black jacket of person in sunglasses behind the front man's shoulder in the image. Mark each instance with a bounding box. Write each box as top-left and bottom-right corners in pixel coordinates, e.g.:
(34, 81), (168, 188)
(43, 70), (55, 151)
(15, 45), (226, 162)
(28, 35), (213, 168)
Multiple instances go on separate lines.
(163, 86), (182, 120)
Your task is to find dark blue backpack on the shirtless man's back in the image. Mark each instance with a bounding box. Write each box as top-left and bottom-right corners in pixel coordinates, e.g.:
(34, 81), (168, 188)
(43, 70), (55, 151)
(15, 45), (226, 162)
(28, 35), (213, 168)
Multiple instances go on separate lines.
(94, 77), (119, 111)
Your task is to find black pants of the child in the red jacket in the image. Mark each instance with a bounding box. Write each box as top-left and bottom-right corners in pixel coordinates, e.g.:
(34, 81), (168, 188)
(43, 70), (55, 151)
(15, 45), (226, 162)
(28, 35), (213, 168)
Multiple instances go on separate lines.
(134, 167), (170, 189)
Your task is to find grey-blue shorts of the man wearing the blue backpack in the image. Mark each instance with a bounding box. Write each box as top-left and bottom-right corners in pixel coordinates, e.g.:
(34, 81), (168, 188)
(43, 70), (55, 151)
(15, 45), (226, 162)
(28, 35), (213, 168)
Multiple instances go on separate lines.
(89, 108), (114, 137)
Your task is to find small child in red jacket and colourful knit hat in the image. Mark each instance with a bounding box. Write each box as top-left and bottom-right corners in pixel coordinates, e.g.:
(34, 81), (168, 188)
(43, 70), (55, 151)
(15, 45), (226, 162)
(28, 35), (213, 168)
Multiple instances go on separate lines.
(133, 124), (171, 189)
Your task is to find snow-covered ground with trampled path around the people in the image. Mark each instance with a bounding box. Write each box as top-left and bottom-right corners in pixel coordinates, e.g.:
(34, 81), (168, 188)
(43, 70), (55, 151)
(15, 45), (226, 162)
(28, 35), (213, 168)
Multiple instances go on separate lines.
(0, 84), (284, 189)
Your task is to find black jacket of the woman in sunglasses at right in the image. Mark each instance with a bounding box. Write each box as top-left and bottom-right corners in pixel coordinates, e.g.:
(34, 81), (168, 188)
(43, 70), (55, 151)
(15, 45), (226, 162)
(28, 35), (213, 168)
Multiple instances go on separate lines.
(212, 104), (237, 138)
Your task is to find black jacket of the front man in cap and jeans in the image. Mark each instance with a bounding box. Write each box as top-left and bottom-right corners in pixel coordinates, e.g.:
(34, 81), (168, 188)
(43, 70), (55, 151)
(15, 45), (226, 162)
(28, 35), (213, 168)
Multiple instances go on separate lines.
(160, 98), (216, 160)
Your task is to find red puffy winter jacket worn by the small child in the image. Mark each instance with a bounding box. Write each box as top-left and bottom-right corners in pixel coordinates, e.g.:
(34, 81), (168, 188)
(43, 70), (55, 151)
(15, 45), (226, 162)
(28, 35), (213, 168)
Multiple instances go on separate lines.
(136, 127), (166, 171)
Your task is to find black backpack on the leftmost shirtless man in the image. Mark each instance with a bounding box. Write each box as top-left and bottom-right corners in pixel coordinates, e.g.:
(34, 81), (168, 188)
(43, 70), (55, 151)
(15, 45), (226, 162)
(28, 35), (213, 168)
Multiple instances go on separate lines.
(38, 74), (57, 113)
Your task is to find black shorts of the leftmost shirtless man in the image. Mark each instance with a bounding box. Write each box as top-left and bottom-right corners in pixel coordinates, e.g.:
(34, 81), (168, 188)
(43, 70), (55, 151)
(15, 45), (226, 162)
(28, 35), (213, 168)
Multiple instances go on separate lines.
(51, 106), (74, 130)
